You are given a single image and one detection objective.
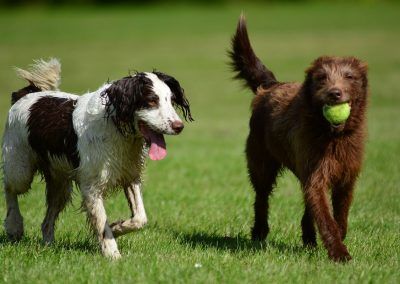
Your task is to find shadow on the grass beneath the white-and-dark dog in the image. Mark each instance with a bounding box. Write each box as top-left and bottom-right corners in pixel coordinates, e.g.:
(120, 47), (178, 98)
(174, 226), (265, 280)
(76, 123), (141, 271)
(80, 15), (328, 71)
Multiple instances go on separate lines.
(0, 233), (99, 255)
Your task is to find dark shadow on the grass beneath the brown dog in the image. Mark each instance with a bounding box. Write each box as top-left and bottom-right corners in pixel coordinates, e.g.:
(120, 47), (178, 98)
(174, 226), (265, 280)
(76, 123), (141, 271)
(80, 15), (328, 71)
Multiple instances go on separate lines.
(176, 232), (306, 254)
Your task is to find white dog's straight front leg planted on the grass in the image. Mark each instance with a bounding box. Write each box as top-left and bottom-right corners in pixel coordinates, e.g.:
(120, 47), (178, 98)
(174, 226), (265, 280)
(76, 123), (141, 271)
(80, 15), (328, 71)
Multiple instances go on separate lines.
(83, 188), (121, 259)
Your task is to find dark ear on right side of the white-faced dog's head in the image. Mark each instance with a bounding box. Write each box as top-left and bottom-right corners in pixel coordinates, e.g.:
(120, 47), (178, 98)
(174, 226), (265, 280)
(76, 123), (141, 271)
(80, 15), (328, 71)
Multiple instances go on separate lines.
(153, 71), (194, 121)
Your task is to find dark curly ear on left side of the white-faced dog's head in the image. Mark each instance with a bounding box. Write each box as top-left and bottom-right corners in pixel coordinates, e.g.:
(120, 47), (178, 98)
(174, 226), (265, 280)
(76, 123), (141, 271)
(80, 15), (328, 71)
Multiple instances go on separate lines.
(101, 73), (152, 136)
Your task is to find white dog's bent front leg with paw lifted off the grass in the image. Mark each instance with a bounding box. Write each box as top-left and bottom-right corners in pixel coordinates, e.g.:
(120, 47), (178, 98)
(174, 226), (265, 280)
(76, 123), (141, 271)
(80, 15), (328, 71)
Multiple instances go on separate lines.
(111, 182), (147, 237)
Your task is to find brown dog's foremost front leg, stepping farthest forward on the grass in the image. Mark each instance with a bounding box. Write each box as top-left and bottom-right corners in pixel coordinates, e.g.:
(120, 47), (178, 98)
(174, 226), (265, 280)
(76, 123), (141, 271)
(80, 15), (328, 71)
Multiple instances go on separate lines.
(304, 173), (351, 261)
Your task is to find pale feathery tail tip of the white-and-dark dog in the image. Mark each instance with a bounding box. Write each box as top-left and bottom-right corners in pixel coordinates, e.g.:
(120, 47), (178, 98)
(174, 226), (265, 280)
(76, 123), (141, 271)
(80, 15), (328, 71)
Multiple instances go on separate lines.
(15, 58), (61, 91)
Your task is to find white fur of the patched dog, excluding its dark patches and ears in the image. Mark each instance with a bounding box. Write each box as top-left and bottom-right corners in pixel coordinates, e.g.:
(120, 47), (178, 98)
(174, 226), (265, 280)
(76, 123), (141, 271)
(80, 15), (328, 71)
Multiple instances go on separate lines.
(2, 60), (189, 259)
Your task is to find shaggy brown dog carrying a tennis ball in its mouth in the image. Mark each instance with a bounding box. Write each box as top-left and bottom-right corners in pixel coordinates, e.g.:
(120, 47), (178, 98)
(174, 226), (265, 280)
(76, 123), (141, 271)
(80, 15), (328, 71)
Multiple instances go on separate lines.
(230, 17), (368, 261)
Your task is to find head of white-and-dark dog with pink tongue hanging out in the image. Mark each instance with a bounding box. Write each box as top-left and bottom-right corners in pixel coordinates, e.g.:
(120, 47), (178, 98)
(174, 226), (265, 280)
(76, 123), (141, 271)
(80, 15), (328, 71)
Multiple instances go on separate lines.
(101, 71), (193, 160)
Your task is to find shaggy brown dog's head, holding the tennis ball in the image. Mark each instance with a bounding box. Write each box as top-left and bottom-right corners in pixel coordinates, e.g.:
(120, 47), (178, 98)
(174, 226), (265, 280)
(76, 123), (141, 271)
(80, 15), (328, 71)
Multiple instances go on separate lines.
(303, 56), (368, 130)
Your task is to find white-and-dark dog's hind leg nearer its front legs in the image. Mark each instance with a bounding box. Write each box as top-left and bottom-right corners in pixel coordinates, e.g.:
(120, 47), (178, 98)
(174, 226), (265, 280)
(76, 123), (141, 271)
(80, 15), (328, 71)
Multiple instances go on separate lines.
(42, 177), (72, 244)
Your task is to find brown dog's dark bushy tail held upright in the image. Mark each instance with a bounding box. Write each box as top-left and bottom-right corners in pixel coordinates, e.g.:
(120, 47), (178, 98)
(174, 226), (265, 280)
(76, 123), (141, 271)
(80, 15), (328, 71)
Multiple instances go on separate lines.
(229, 15), (278, 93)
